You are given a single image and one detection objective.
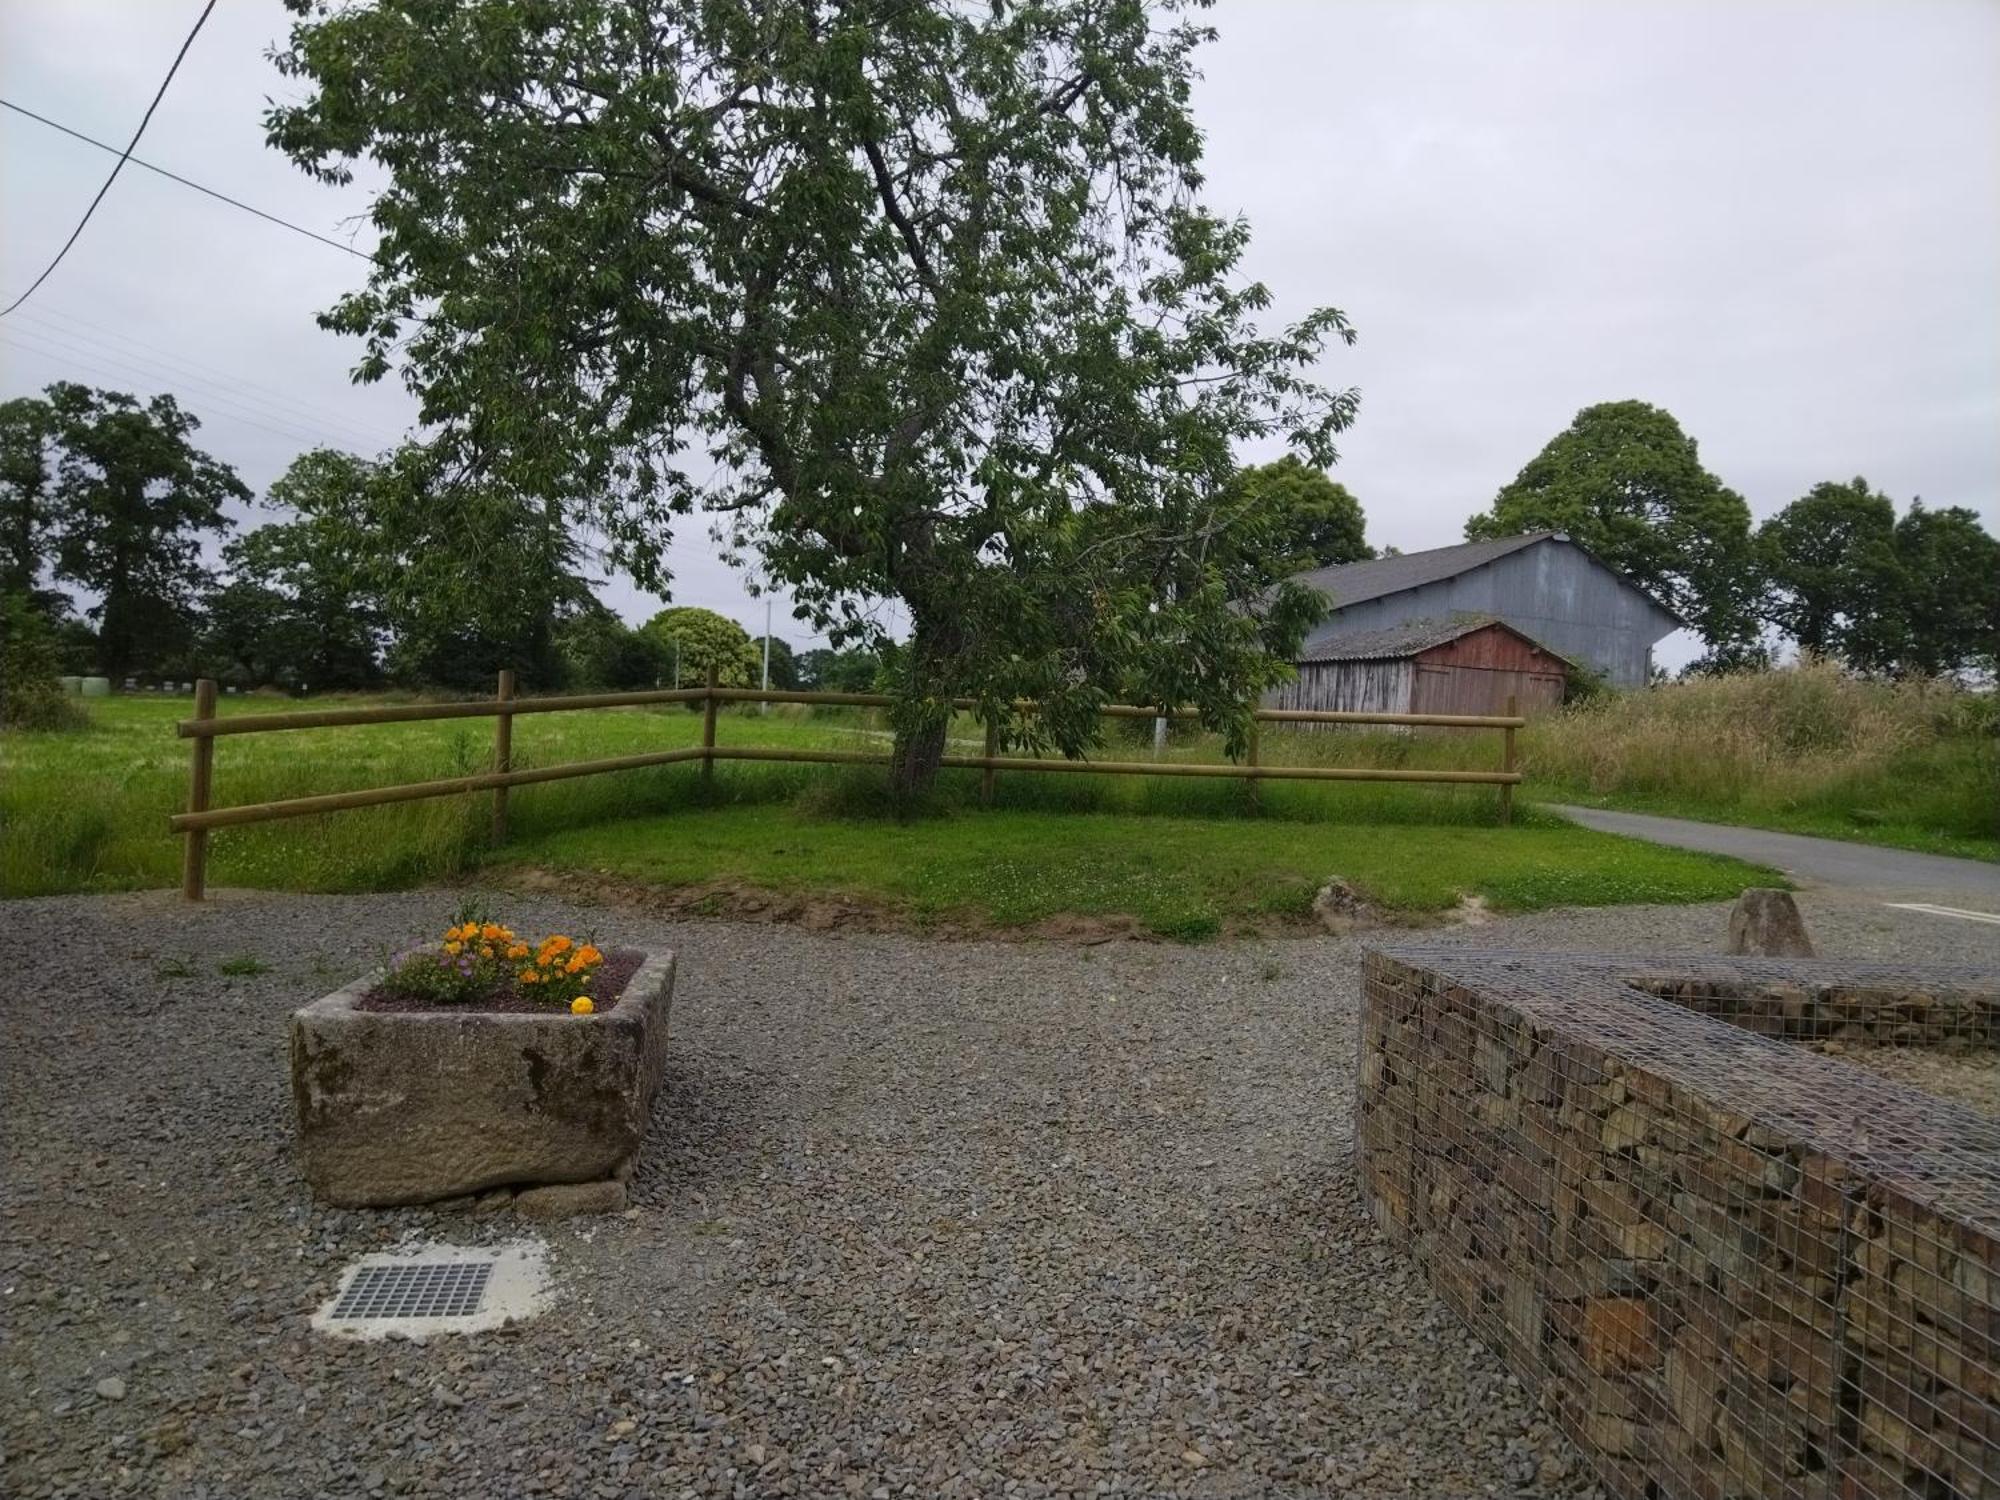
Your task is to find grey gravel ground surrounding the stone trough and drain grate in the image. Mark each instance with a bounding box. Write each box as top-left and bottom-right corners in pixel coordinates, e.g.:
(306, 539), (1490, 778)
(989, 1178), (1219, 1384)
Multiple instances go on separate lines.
(0, 892), (2000, 1500)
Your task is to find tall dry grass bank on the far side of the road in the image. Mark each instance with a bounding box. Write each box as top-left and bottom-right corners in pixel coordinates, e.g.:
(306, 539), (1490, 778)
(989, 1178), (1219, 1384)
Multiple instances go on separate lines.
(1522, 664), (2000, 860)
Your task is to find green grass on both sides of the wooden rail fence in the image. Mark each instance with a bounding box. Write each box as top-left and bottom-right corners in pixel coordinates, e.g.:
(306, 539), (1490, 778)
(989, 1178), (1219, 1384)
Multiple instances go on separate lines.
(0, 698), (1770, 936)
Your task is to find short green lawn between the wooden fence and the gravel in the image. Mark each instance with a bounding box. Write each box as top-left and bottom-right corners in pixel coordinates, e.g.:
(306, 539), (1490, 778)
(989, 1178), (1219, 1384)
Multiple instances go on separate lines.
(504, 804), (1782, 938)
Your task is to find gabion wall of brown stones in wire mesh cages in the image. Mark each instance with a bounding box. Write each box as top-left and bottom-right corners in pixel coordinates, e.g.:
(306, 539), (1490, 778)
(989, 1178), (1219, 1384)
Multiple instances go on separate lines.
(1356, 950), (2000, 1500)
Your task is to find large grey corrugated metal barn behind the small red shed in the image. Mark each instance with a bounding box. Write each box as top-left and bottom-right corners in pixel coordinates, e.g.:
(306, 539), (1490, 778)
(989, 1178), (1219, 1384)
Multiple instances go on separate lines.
(1306, 542), (1678, 688)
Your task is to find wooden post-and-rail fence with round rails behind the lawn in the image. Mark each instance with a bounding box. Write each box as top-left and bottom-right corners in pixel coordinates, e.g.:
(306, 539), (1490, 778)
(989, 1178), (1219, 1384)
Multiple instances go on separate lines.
(168, 670), (1526, 902)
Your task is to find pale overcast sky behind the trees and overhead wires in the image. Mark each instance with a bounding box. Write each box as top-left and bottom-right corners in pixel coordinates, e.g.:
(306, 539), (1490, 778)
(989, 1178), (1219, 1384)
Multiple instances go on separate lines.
(0, 0), (2000, 666)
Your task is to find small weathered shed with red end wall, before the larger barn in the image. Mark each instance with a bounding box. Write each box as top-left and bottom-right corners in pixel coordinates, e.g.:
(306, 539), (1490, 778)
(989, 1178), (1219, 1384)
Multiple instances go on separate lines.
(1264, 614), (1570, 714)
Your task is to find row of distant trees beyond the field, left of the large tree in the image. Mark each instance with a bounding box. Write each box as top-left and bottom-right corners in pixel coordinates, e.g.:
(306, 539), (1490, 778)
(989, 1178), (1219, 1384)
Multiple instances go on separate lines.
(0, 382), (880, 722)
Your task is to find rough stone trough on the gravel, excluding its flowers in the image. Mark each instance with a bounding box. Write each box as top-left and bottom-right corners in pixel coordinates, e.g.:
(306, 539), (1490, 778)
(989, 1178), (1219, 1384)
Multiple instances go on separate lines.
(292, 954), (674, 1208)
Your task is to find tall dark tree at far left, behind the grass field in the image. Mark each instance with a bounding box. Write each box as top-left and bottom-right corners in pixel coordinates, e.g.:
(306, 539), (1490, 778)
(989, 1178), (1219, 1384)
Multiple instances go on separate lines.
(48, 382), (250, 678)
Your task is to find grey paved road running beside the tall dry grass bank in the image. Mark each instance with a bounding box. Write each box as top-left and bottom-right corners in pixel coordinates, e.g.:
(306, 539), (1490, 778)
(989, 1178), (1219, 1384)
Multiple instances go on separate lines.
(1548, 804), (2000, 912)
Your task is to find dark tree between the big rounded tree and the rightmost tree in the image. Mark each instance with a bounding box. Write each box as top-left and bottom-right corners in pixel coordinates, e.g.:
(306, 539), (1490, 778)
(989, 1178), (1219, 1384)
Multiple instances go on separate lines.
(1756, 478), (1902, 656)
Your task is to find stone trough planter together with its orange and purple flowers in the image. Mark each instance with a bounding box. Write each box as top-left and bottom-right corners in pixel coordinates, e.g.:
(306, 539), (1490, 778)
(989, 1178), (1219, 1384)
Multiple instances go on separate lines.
(292, 920), (674, 1208)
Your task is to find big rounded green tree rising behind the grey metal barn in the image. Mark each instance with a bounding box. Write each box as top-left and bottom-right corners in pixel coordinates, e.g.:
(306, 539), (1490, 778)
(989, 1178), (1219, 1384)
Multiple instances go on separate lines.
(1466, 402), (1758, 660)
